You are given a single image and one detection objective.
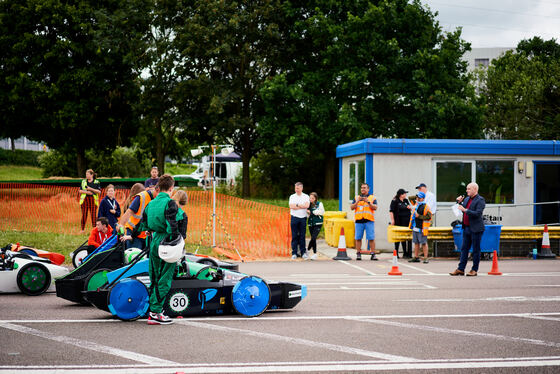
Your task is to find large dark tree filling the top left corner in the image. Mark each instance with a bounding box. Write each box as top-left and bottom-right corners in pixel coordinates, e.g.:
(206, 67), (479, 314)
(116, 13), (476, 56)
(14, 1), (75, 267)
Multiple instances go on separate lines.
(0, 0), (150, 175)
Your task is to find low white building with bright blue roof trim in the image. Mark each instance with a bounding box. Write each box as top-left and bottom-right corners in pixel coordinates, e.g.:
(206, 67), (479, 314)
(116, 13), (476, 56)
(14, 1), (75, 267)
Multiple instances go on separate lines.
(336, 138), (560, 249)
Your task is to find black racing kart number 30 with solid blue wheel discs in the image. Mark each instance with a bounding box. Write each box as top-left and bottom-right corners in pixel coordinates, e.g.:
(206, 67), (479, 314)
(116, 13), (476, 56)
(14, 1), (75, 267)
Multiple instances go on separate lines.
(82, 250), (307, 321)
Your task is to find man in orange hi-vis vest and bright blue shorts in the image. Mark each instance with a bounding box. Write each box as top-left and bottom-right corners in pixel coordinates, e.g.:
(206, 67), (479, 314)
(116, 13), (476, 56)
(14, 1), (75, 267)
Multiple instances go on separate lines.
(350, 183), (377, 261)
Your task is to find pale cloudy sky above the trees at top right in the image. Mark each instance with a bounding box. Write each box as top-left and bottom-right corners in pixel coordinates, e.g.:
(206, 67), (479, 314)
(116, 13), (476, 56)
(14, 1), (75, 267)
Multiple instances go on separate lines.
(421, 0), (560, 48)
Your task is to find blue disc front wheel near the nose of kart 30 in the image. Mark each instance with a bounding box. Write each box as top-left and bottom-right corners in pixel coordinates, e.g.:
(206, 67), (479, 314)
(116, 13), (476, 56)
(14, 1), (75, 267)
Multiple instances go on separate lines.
(231, 276), (270, 317)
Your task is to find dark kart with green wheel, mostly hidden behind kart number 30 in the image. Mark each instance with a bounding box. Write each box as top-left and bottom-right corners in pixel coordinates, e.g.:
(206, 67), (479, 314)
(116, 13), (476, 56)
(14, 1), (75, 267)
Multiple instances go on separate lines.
(55, 235), (239, 305)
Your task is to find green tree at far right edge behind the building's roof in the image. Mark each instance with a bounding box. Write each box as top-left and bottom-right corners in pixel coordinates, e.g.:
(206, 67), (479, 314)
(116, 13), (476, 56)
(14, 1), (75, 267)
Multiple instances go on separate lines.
(481, 37), (560, 140)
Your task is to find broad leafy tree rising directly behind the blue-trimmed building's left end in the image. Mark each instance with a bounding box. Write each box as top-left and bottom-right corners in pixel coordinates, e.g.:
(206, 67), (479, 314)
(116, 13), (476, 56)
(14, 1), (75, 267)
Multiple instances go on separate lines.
(258, 0), (481, 197)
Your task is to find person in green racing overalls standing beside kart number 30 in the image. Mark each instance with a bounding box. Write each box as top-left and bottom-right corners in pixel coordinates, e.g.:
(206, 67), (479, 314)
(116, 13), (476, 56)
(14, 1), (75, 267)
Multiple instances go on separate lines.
(140, 174), (184, 325)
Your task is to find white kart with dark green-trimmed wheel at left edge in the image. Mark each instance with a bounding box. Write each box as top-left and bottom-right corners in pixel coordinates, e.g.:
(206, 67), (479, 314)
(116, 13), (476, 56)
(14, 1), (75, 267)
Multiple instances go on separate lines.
(0, 245), (68, 296)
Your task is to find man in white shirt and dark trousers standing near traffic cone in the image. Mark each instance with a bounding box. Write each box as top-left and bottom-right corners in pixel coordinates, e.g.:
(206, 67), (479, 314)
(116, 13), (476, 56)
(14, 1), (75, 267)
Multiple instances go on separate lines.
(289, 182), (309, 260)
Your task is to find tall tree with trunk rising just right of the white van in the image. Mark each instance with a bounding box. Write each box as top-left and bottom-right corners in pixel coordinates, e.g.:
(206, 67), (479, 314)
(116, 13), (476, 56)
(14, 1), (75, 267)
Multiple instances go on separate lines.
(176, 0), (282, 196)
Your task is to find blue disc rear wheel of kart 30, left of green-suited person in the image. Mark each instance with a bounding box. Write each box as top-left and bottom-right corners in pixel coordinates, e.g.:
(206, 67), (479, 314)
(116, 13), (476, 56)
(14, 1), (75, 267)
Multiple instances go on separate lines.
(107, 278), (150, 321)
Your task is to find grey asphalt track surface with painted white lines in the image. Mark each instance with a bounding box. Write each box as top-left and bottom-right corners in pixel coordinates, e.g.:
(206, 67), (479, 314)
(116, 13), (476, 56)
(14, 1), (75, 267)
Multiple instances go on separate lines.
(0, 241), (560, 373)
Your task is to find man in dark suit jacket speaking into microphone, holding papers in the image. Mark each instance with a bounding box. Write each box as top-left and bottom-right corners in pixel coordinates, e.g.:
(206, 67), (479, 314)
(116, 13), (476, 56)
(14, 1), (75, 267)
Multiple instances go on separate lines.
(449, 182), (486, 277)
